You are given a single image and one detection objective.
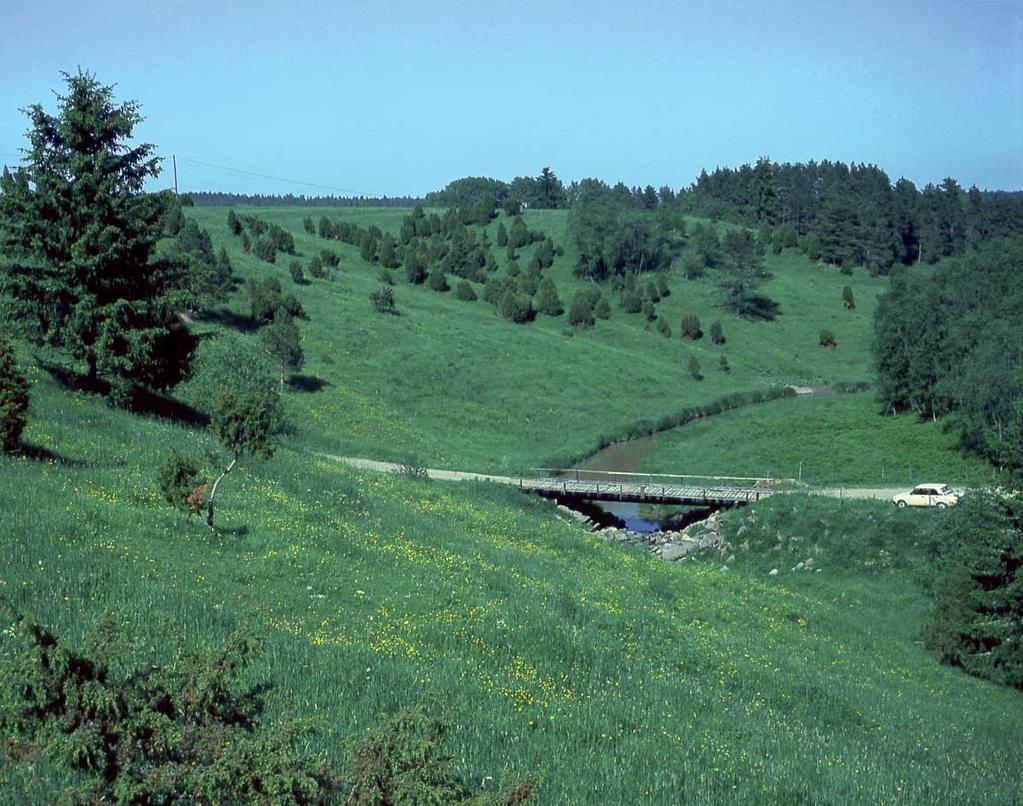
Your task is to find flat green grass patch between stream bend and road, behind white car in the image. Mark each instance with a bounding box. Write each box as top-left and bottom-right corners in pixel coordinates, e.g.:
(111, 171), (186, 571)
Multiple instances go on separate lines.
(641, 393), (991, 487)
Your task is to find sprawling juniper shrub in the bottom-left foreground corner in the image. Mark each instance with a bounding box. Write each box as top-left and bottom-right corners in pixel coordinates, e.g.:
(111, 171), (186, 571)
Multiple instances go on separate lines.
(0, 613), (340, 804)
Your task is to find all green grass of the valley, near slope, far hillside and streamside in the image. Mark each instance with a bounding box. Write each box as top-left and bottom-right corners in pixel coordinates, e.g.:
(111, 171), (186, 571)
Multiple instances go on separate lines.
(0, 209), (1023, 804)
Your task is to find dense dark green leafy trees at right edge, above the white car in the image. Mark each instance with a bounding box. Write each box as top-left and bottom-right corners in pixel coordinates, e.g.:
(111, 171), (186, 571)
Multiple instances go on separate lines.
(875, 237), (1023, 472)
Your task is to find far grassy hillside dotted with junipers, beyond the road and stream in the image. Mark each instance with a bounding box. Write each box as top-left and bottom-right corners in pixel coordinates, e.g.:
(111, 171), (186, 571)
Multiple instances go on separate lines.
(189, 208), (885, 472)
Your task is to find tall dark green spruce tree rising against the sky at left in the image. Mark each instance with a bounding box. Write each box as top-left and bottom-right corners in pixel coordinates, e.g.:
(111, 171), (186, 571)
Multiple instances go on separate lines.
(0, 72), (196, 389)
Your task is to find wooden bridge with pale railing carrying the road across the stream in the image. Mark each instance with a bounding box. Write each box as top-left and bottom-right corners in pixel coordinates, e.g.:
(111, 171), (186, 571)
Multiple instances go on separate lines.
(518, 467), (773, 508)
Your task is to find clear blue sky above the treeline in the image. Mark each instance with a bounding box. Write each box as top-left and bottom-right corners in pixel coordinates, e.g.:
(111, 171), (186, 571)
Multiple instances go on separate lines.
(0, 0), (1023, 195)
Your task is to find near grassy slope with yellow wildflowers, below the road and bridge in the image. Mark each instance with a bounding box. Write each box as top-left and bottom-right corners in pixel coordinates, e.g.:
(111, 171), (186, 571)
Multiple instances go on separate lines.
(0, 369), (1023, 803)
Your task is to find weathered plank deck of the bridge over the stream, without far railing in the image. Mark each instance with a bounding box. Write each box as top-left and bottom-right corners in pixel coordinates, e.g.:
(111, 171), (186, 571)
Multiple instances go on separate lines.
(519, 478), (771, 506)
